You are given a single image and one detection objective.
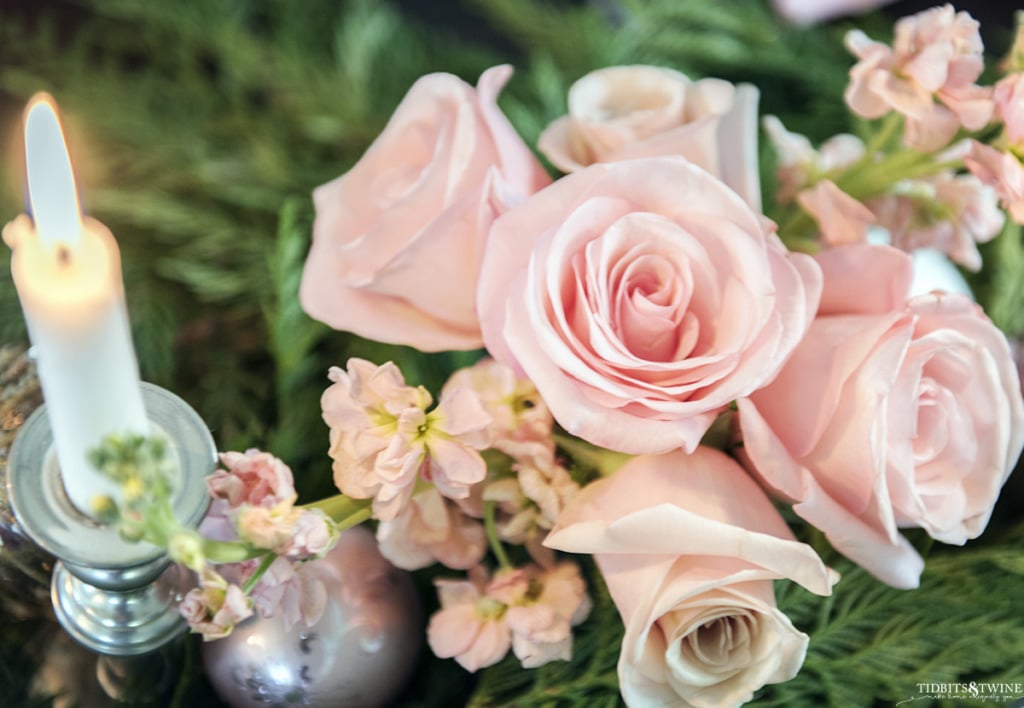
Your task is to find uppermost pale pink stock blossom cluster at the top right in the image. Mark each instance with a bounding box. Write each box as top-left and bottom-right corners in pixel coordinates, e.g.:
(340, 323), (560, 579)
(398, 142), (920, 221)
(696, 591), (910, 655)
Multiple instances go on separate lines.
(846, 4), (993, 151)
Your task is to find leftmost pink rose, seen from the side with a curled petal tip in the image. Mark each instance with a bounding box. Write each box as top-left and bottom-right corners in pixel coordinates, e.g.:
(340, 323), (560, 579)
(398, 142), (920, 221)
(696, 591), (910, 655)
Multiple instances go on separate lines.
(299, 66), (550, 351)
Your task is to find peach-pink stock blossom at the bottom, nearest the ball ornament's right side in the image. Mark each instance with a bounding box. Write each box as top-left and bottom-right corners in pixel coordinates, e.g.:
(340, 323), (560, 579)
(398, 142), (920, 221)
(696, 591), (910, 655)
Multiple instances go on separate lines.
(427, 567), (512, 671)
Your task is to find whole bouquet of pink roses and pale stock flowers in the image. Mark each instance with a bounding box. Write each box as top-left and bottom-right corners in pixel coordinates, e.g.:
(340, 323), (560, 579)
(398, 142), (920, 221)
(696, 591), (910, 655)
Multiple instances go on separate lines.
(6, 5), (1024, 706)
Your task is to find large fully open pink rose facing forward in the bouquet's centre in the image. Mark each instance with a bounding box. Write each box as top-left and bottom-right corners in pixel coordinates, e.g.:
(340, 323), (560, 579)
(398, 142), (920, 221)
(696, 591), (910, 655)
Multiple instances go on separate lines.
(479, 158), (820, 453)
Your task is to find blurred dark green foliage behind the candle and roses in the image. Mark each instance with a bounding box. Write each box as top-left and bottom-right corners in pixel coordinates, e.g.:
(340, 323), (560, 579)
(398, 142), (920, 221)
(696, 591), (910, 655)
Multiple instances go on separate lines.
(0, 0), (1024, 706)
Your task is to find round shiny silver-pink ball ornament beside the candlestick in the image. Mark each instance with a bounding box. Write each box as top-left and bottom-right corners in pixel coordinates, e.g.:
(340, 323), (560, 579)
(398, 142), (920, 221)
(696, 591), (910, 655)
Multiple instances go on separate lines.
(203, 527), (424, 708)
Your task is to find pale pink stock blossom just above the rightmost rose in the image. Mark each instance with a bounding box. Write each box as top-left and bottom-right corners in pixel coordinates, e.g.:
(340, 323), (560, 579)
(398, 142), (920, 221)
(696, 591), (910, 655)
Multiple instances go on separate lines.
(870, 172), (1006, 272)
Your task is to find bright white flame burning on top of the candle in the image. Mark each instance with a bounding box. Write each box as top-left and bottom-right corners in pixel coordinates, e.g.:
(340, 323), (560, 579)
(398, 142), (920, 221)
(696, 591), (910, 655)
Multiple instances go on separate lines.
(25, 93), (82, 249)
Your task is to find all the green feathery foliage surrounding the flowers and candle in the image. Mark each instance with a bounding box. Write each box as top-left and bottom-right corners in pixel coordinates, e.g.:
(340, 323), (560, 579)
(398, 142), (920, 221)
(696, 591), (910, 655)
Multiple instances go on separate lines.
(0, 0), (1024, 708)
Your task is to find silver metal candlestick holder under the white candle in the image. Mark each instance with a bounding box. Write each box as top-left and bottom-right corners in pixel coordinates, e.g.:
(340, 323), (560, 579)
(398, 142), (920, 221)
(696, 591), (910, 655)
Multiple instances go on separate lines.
(7, 383), (216, 657)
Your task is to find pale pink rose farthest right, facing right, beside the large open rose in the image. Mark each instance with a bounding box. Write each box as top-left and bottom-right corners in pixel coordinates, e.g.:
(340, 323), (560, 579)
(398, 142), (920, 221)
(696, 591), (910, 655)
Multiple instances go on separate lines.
(738, 246), (1024, 588)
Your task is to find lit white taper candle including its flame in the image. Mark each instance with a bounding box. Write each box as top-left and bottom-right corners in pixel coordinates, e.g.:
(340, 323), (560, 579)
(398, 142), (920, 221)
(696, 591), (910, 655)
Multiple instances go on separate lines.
(3, 94), (150, 513)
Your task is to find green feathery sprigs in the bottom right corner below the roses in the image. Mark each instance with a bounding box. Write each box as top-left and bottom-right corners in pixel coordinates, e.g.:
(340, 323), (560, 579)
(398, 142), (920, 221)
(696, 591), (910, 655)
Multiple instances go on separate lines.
(759, 526), (1024, 706)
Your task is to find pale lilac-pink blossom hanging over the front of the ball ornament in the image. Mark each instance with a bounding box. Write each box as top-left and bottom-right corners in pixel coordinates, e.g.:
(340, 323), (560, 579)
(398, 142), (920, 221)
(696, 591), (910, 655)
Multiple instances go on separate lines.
(252, 557), (327, 631)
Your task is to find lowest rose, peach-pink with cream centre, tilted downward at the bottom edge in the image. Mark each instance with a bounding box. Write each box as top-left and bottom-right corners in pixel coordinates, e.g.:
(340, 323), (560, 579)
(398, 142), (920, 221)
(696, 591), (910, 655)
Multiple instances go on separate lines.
(547, 447), (838, 708)
